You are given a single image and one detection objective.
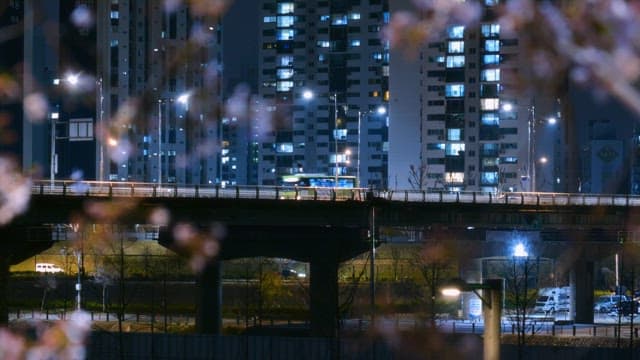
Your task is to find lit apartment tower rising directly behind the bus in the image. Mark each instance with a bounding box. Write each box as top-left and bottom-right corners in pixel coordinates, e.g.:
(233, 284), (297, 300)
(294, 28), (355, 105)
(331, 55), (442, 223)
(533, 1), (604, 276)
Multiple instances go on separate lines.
(255, 0), (389, 188)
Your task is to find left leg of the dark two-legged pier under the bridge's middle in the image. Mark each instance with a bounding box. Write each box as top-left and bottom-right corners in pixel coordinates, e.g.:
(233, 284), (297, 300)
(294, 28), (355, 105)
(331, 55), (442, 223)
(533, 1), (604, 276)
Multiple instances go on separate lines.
(196, 261), (222, 334)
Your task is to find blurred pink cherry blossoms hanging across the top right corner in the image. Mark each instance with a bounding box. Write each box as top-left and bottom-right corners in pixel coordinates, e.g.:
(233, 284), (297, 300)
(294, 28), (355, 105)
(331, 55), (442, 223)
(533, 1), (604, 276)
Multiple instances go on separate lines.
(383, 0), (640, 113)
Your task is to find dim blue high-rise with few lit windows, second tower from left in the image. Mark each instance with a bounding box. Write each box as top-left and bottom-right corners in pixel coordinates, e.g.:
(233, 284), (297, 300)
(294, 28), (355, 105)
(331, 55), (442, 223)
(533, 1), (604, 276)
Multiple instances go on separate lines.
(95, 0), (222, 184)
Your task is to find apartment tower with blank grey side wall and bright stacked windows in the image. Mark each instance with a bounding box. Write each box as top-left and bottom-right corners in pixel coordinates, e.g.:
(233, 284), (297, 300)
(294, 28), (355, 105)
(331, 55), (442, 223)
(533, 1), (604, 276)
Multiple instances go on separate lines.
(389, 0), (565, 192)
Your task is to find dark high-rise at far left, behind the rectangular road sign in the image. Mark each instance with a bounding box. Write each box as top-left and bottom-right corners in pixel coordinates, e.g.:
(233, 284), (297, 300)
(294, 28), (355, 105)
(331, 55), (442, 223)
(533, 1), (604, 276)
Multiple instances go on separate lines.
(0, 0), (95, 180)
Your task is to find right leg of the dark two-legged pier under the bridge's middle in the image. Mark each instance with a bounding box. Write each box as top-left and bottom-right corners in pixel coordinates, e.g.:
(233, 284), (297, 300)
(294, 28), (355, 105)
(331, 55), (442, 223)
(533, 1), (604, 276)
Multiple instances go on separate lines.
(310, 256), (338, 337)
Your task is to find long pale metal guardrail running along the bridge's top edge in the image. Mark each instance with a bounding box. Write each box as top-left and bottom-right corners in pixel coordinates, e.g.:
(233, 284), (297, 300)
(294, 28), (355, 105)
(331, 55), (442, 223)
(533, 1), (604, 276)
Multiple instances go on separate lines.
(32, 180), (640, 206)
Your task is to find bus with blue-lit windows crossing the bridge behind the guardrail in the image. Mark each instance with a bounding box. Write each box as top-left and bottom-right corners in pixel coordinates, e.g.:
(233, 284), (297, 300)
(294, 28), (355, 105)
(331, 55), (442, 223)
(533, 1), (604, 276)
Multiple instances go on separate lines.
(280, 173), (360, 200)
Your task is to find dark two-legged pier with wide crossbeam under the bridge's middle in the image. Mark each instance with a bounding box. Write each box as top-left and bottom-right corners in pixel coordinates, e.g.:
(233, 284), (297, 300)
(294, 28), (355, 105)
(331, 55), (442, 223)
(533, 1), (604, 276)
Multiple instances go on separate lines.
(159, 225), (371, 337)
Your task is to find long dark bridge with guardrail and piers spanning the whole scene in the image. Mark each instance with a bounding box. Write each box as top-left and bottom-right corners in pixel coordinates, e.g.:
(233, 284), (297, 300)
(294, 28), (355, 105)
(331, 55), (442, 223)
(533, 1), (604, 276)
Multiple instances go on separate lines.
(0, 181), (640, 336)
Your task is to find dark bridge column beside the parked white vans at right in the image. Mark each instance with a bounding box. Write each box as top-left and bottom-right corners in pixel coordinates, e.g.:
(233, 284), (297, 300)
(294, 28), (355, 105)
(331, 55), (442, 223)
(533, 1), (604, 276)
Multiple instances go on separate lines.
(570, 259), (594, 324)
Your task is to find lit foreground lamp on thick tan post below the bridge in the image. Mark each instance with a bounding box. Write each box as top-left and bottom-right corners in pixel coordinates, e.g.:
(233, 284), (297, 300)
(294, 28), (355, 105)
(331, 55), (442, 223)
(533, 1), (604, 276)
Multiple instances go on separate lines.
(441, 279), (504, 360)
